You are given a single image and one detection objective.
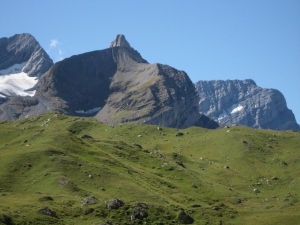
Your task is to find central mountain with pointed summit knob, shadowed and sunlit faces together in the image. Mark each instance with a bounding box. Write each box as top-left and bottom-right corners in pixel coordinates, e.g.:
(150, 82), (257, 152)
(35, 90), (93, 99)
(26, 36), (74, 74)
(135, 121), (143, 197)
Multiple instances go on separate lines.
(0, 35), (208, 128)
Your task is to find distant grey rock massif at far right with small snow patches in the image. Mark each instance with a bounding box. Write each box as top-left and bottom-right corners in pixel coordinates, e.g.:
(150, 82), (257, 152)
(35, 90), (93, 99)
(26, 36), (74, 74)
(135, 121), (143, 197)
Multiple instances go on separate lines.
(195, 79), (300, 130)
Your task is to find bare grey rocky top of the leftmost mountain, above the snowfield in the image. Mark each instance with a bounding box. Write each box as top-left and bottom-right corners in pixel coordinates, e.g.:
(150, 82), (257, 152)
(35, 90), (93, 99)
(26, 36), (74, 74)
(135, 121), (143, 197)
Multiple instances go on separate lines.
(0, 34), (53, 77)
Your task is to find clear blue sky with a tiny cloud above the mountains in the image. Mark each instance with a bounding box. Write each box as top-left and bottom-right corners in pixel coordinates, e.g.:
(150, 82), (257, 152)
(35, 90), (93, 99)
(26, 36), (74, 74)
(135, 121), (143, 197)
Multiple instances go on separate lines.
(0, 0), (300, 123)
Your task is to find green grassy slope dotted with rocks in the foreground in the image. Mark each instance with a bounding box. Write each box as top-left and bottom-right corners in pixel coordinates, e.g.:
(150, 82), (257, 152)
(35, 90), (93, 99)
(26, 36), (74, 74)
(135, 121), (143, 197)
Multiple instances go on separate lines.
(0, 114), (300, 225)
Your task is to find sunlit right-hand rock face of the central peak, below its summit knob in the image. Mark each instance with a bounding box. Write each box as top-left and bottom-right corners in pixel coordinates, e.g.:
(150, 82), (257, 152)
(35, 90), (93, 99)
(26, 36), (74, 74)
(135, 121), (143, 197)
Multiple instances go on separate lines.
(96, 47), (199, 128)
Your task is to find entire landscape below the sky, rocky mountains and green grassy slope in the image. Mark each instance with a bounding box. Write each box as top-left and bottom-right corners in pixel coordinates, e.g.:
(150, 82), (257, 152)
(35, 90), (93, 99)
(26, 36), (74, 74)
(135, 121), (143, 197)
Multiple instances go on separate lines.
(0, 34), (300, 225)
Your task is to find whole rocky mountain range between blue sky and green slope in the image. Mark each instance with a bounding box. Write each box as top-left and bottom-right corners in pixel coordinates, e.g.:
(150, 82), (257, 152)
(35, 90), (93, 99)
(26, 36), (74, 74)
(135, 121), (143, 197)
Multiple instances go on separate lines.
(0, 34), (300, 130)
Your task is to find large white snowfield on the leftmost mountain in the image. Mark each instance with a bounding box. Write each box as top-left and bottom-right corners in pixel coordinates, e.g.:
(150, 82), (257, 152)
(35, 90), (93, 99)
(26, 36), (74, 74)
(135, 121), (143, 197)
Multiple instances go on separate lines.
(0, 62), (38, 98)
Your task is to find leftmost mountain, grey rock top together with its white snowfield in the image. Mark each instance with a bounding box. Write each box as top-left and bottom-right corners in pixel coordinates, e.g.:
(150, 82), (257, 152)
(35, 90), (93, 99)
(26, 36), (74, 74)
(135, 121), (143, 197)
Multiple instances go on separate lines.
(0, 34), (53, 100)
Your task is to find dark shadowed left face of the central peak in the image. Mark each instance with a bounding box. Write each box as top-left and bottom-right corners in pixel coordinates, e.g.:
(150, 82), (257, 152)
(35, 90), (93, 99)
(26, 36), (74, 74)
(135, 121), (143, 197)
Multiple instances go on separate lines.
(36, 49), (116, 115)
